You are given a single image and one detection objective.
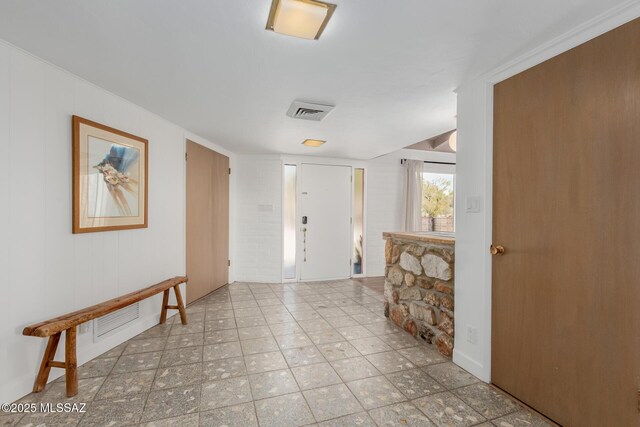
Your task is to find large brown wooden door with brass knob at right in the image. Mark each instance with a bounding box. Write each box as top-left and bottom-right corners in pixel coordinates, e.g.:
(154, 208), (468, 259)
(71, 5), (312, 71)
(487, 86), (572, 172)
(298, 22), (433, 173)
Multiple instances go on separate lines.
(491, 20), (640, 427)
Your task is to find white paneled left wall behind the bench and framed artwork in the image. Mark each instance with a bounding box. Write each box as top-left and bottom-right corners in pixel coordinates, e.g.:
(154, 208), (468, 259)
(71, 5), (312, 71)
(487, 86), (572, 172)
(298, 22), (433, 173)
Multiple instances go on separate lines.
(0, 41), (235, 402)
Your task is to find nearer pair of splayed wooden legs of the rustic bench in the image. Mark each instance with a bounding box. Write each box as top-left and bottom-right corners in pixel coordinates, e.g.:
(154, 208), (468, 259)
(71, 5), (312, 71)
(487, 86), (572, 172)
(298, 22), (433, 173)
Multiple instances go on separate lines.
(33, 326), (78, 397)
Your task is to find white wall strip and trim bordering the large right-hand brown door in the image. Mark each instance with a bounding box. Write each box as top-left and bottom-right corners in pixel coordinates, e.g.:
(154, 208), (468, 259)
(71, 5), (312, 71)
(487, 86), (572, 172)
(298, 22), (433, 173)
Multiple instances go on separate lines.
(453, 1), (640, 382)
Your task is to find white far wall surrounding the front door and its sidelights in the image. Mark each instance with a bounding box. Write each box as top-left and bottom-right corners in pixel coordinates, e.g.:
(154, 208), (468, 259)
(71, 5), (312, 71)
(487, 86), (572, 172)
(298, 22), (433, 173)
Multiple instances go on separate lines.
(232, 150), (456, 283)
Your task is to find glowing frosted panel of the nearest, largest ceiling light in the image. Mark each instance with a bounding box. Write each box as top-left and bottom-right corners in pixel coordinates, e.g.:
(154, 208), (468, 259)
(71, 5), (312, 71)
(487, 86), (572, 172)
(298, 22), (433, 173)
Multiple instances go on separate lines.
(273, 0), (329, 40)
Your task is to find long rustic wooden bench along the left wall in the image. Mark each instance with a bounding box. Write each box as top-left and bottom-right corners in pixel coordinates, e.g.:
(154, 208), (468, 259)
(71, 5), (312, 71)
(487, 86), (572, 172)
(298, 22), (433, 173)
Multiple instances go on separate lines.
(22, 276), (187, 397)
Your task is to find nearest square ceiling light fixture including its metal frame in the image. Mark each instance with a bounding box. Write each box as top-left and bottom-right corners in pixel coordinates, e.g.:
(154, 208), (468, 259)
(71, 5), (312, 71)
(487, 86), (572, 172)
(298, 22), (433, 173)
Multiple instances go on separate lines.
(267, 0), (337, 40)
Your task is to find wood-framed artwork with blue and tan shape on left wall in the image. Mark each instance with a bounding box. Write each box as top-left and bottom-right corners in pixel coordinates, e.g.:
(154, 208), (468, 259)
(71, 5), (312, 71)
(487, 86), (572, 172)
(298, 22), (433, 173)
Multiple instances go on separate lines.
(73, 116), (149, 233)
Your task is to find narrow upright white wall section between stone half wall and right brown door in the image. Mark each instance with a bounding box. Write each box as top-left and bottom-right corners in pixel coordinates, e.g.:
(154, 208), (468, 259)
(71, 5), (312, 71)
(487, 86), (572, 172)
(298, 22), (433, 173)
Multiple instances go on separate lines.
(453, 82), (491, 381)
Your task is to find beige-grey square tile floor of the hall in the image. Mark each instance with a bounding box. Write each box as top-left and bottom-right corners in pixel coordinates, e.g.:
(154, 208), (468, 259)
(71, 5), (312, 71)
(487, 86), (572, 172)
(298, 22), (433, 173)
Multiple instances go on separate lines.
(5, 280), (550, 427)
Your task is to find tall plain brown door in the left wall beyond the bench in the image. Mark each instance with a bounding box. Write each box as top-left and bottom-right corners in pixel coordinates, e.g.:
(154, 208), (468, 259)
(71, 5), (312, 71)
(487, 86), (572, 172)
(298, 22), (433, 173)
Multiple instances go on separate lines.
(187, 141), (229, 303)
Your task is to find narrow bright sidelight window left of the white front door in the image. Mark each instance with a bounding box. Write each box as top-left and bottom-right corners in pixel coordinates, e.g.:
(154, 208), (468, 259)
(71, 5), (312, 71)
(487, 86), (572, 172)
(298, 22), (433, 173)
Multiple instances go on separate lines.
(282, 165), (296, 279)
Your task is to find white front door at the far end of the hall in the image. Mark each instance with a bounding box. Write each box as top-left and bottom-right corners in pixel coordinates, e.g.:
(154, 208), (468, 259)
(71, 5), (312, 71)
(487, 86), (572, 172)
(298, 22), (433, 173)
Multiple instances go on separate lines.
(299, 164), (351, 280)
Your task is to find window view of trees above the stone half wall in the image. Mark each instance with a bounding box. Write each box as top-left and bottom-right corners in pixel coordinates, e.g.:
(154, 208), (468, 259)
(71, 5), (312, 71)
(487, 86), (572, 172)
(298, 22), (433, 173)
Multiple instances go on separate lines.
(422, 172), (454, 232)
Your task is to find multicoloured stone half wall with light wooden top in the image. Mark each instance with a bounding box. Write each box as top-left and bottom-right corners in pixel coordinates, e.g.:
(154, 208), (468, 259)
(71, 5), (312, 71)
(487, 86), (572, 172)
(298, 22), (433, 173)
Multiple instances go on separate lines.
(383, 233), (455, 357)
